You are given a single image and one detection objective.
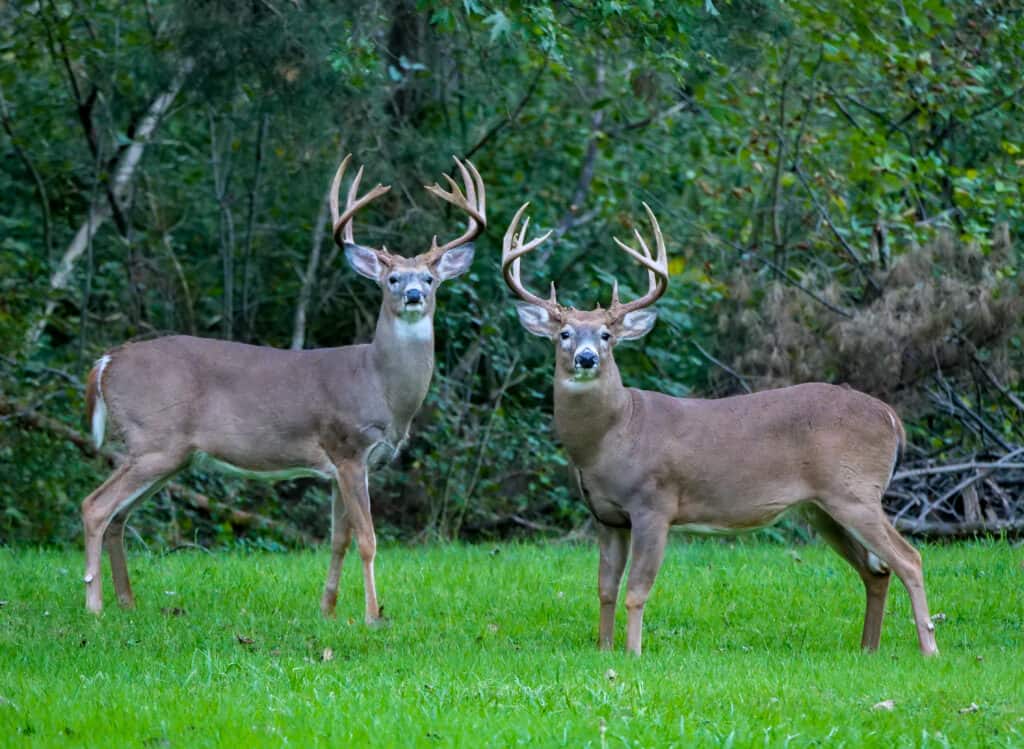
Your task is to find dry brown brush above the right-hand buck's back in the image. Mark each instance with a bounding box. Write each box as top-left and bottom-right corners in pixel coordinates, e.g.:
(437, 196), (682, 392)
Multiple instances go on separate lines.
(719, 227), (1024, 411)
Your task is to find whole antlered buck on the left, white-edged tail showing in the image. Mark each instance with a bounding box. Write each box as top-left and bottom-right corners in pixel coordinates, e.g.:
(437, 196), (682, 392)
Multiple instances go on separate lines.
(82, 156), (486, 623)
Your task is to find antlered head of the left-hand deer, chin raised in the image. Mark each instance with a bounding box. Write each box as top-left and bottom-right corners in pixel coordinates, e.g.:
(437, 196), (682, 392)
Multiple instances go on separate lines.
(331, 155), (487, 322)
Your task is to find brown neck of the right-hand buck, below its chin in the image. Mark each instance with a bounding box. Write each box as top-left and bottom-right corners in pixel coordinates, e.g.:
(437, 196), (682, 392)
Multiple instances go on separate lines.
(555, 361), (632, 467)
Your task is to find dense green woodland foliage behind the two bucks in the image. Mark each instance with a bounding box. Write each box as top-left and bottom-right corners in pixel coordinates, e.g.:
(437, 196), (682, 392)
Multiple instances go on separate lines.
(0, 0), (1024, 542)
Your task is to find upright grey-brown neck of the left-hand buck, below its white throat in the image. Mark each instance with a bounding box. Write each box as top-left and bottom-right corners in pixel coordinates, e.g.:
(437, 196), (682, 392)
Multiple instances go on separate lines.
(373, 309), (434, 439)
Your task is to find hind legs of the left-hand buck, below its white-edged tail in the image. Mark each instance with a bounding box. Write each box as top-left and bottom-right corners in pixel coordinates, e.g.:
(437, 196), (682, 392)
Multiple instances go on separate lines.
(82, 455), (180, 614)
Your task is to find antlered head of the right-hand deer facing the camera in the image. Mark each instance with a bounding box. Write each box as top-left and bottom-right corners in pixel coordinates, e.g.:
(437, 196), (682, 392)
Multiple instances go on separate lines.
(502, 203), (669, 387)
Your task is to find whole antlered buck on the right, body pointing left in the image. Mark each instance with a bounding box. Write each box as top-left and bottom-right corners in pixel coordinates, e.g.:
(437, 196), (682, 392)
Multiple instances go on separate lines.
(502, 204), (938, 655)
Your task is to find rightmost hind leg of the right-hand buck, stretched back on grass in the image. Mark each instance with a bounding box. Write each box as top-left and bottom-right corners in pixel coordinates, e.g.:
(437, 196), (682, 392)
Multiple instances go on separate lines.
(825, 499), (939, 656)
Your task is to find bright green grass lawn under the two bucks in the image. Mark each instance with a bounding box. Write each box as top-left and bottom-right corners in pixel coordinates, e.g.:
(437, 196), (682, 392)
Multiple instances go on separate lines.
(0, 542), (1024, 747)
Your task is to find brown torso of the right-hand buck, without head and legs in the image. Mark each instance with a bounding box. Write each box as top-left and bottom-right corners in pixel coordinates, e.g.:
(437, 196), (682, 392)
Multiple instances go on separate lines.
(555, 383), (899, 532)
